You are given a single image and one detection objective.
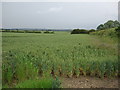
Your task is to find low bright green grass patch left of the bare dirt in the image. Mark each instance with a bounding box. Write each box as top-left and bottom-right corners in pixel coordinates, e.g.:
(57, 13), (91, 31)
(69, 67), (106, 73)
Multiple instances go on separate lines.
(15, 77), (60, 88)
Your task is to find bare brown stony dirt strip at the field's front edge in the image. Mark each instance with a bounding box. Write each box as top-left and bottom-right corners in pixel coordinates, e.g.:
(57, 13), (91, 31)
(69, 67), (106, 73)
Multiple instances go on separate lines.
(60, 76), (118, 88)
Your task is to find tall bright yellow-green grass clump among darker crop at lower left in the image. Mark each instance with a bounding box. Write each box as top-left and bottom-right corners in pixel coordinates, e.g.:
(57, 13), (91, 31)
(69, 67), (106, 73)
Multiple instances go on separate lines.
(15, 61), (38, 82)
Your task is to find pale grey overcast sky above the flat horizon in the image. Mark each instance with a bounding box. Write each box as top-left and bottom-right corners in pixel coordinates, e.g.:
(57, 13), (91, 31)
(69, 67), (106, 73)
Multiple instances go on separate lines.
(2, 2), (118, 29)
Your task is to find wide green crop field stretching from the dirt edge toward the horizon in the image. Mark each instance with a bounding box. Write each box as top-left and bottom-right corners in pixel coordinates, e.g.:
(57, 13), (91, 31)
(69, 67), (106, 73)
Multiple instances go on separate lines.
(2, 31), (119, 86)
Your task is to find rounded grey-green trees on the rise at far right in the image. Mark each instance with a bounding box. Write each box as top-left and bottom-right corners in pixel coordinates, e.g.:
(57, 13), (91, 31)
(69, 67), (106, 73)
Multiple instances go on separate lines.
(97, 20), (120, 30)
